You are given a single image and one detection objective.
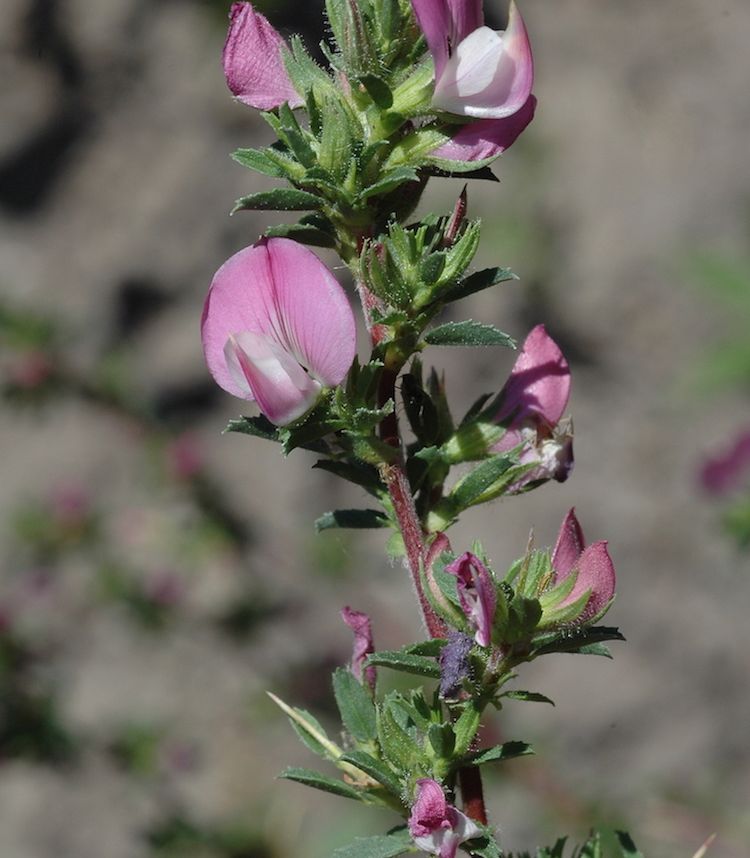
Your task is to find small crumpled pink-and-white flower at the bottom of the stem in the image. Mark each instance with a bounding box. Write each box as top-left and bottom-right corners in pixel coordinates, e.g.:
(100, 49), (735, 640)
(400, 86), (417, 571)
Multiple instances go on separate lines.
(409, 778), (482, 858)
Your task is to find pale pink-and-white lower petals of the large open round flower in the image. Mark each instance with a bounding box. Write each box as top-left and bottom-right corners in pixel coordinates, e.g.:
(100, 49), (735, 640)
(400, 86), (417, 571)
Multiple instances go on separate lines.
(224, 331), (321, 426)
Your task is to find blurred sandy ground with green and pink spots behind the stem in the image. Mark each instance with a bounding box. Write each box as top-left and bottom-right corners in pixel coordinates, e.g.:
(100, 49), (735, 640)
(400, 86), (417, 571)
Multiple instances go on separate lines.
(0, 0), (750, 858)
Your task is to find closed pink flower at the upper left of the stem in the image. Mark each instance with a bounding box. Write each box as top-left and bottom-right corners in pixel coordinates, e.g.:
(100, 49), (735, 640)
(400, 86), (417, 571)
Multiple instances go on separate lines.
(223, 3), (304, 110)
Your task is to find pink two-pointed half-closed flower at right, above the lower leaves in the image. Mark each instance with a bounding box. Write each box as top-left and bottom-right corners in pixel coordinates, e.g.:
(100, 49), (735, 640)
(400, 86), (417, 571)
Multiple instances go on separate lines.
(552, 509), (616, 622)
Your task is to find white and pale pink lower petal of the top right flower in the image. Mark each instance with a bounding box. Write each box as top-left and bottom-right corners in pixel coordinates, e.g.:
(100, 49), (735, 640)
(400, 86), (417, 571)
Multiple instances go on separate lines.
(432, 2), (534, 119)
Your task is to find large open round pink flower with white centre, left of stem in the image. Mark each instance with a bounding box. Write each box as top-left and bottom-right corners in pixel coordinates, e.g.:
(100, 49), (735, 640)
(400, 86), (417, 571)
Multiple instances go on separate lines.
(201, 238), (355, 426)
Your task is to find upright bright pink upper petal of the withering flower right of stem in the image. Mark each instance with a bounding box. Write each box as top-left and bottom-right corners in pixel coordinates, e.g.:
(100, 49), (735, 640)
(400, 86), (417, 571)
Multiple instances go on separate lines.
(495, 325), (570, 429)
